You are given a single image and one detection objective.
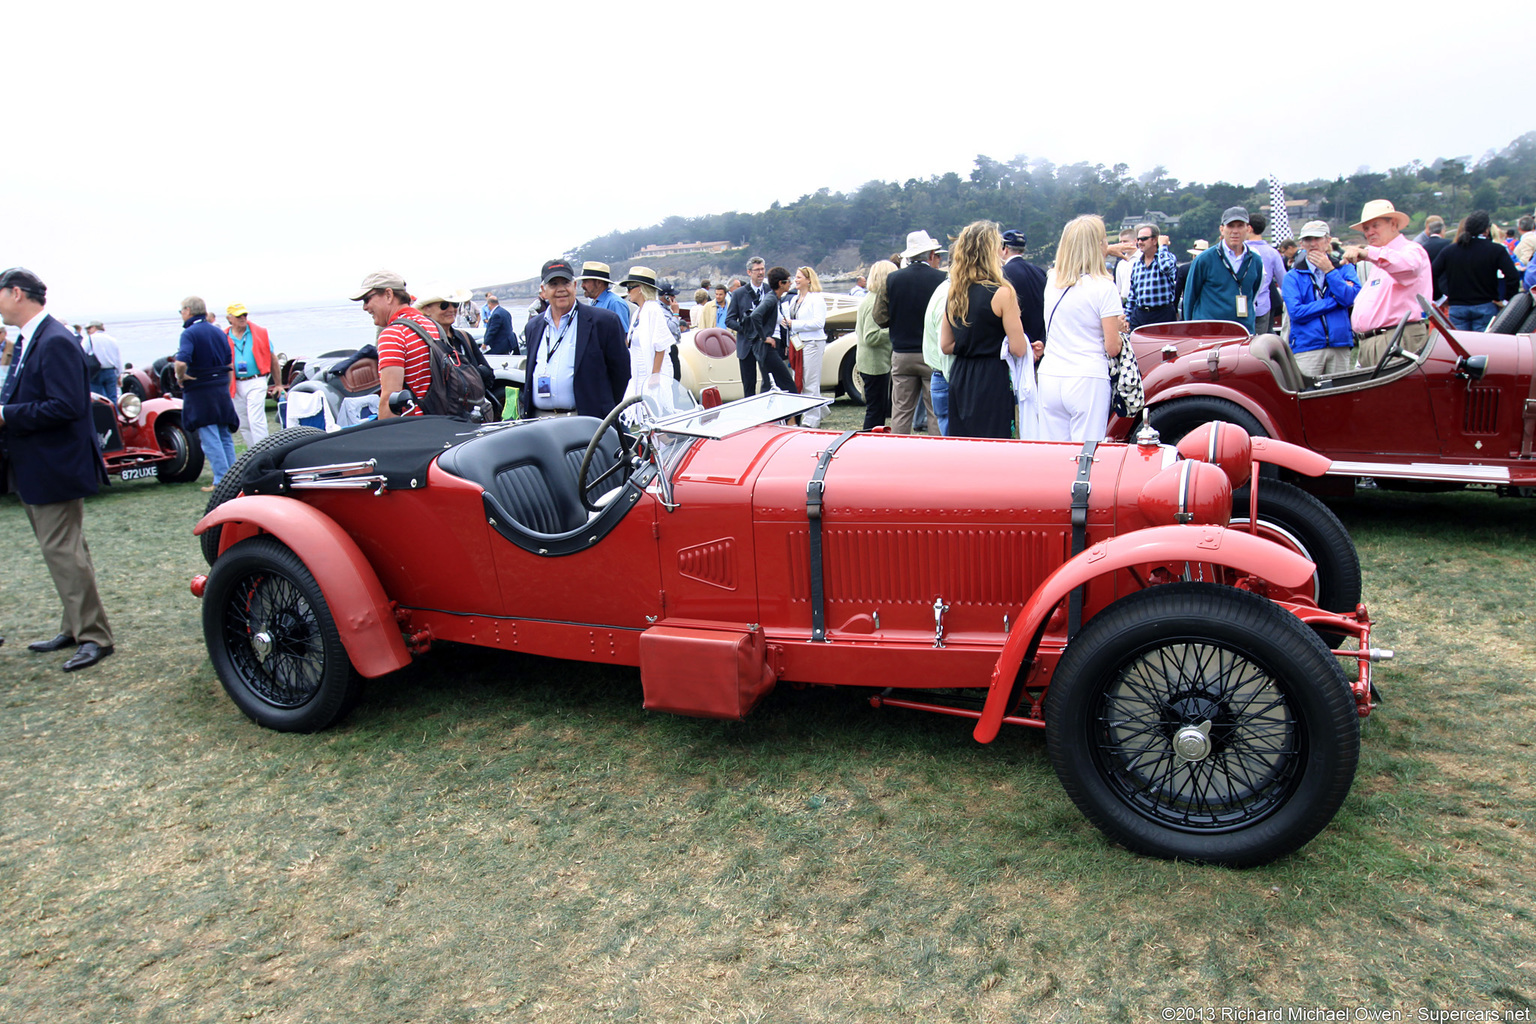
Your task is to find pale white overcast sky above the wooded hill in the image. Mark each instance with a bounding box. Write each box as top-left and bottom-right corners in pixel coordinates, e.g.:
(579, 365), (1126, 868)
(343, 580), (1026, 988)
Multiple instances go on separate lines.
(9, 0), (1536, 319)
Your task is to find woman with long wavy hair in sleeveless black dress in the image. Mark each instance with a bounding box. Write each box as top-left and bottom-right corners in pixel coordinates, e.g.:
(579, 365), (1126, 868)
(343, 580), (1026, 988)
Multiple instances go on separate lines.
(938, 221), (1029, 438)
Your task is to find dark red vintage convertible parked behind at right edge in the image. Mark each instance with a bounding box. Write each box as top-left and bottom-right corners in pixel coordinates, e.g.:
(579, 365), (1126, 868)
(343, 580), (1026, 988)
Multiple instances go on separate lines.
(1109, 299), (1536, 494)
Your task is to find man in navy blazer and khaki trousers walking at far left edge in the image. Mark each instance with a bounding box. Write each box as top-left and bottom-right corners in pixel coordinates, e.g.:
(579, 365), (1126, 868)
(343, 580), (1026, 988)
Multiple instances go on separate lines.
(0, 267), (112, 672)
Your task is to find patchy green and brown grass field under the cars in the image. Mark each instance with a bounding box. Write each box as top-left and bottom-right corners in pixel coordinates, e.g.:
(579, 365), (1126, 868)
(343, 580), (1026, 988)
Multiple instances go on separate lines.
(0, 407), (1536, 1024)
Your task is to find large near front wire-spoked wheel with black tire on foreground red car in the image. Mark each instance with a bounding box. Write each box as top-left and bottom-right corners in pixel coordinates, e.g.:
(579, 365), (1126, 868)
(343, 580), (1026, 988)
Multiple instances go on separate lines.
(1044, 583), (1359, 867)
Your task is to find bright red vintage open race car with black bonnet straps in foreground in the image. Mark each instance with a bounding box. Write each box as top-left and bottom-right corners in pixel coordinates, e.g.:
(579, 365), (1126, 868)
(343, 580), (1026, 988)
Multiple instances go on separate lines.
(192, 382), (1390, 864)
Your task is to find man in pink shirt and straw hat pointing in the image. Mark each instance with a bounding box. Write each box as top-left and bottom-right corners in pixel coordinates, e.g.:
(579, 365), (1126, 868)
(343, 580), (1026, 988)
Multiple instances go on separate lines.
(1344, 200), (1435, 368)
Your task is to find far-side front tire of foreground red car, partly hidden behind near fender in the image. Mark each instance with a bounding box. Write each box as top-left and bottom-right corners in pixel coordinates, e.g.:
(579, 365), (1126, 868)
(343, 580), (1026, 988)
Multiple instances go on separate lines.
(1232, 481), (1361, 632)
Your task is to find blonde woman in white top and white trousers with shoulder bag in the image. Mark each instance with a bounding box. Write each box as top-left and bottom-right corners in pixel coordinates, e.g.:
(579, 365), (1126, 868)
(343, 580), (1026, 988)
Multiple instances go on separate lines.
(1035, 215), (1126, 444)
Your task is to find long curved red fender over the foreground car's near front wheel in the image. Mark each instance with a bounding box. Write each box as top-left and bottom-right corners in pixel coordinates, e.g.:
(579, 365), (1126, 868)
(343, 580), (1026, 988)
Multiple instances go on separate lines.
(972, 527), (1316, 743)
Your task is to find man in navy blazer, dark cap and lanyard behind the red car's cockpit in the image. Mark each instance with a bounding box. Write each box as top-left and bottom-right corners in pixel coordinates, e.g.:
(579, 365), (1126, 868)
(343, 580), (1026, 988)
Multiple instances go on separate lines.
(518, 259), (630, 419)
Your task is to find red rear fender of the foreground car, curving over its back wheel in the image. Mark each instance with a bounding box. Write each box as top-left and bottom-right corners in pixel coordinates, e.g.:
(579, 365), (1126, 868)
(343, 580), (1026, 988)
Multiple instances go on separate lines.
(192, 494), (410, 679)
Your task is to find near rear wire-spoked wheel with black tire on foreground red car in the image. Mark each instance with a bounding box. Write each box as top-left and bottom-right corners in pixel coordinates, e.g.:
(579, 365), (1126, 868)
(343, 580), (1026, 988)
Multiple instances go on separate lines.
(203, 537), (358, 732)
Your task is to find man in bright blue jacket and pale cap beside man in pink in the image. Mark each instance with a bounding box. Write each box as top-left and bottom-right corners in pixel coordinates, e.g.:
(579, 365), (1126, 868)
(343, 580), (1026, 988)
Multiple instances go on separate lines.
(1279, 221), (1359, 378)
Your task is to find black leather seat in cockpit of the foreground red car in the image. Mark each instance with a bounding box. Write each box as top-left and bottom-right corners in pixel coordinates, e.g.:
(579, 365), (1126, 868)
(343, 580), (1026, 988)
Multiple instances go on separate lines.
(438, 416), (619, 539)
